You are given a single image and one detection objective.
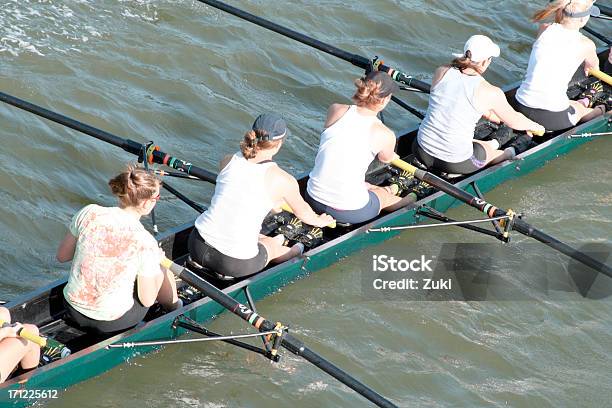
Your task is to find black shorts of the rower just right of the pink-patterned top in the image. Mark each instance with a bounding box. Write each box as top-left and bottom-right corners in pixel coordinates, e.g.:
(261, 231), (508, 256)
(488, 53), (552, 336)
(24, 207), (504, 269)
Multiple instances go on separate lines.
(188, 228), (268, 278)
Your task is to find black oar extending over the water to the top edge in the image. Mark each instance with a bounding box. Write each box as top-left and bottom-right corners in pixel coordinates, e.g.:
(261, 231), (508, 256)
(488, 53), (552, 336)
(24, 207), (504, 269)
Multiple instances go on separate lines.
(198, 0), (431, 119)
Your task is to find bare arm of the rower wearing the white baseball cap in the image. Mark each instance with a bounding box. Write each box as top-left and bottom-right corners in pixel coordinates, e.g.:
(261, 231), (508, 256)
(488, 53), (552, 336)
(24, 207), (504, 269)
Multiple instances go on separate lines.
(476, 82), (544, 132)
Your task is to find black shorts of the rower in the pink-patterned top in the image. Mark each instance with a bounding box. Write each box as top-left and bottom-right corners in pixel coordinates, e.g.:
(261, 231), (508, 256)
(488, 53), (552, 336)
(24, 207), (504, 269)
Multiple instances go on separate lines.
(64, 284), (149, 335)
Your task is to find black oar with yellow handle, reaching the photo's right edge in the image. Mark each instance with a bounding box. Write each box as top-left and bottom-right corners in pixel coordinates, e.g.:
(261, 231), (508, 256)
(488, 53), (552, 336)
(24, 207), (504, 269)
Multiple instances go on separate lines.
(391, 159), (612, 278)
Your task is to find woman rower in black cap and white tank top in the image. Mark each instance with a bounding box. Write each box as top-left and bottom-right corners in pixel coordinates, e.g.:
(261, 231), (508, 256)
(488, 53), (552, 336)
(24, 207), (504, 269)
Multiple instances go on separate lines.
(306, 71), (416, 224)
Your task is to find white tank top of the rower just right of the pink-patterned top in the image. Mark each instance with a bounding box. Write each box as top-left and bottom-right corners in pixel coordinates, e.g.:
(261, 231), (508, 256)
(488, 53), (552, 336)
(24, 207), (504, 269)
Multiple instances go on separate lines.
(195, 152), (275, 259)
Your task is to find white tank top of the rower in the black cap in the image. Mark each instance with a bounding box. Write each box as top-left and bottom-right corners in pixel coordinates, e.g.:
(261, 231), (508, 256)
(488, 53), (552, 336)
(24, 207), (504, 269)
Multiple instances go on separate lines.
(307, 105), (380, 210)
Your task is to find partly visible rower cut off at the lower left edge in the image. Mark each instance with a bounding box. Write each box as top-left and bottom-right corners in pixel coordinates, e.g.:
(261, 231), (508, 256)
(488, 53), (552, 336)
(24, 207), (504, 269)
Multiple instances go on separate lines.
(0, 307), (40, 383)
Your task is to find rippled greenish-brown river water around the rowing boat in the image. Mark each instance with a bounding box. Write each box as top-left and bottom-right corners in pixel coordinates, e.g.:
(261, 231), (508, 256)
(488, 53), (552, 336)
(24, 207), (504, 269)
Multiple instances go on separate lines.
(0, 0), (612, 408)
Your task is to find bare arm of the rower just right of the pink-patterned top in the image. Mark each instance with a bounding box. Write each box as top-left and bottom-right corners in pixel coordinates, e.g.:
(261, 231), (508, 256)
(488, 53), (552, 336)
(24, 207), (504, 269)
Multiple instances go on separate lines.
(268, 167), (334, 228)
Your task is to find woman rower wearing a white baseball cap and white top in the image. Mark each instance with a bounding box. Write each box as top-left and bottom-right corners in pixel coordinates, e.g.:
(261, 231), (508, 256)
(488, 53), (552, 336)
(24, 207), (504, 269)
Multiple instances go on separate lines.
(415, 35), (544, 174)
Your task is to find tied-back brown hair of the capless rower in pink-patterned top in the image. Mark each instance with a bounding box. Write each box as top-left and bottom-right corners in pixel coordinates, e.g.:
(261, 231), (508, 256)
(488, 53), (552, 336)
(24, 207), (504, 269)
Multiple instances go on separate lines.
(108, 165), (161, 207)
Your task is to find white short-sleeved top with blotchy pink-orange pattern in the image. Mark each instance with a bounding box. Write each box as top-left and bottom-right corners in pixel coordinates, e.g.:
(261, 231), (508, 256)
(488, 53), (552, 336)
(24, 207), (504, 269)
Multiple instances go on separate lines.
(64, 204), (163, 321)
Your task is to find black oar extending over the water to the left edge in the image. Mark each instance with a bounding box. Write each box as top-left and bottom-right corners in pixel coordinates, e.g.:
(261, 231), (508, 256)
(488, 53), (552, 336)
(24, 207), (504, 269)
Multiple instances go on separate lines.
(0, 92), (217, 184)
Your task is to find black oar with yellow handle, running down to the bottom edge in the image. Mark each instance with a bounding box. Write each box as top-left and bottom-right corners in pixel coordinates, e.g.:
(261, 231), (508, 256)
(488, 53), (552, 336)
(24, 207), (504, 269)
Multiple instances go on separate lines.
(161, 258), (397, 408)
